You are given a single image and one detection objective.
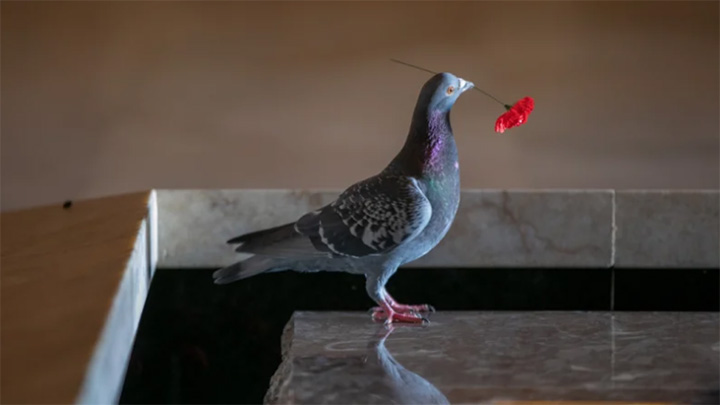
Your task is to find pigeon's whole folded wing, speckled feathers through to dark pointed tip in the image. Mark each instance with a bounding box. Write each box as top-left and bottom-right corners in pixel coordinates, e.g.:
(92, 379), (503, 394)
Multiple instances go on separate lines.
(222, 175), (432, 258)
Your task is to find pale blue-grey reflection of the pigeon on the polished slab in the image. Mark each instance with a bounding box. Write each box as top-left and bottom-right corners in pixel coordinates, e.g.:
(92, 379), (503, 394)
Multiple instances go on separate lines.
(374, 327), (450, 404)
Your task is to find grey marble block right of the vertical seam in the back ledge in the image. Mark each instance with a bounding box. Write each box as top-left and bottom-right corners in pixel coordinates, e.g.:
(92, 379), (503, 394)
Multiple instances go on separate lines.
(615, 190), (720, 268)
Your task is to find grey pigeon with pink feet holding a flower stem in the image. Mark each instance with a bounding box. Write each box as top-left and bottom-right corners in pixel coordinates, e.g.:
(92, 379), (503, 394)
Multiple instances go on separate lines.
(213, 72), (474, 324)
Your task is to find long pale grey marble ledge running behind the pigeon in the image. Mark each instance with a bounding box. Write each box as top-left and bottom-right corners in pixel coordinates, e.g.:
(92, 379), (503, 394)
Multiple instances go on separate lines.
(158, 189), (720, 268)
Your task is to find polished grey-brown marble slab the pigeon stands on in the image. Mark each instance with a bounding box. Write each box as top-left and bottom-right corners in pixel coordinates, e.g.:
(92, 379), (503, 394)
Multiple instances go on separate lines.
(266, 312), (720, 404)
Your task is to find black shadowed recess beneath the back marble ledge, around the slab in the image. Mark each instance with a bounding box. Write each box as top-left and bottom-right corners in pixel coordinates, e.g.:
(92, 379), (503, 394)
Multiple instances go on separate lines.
(120, 268), (719, 403)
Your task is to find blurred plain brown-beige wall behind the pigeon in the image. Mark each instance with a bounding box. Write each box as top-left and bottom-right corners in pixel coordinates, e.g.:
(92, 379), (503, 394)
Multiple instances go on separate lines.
(1, 1), (719, 210)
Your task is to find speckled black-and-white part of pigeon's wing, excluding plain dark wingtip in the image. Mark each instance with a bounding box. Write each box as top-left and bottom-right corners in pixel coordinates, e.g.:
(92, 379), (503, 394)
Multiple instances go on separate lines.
(295, 175), (432, 257)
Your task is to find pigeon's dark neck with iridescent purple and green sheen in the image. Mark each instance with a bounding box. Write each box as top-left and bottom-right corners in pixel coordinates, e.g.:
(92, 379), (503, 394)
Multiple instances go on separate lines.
(391, 110), (458, 176)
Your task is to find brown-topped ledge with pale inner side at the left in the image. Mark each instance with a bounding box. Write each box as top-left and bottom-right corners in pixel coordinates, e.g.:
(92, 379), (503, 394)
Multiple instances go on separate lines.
(1, 191), (157, 404)
